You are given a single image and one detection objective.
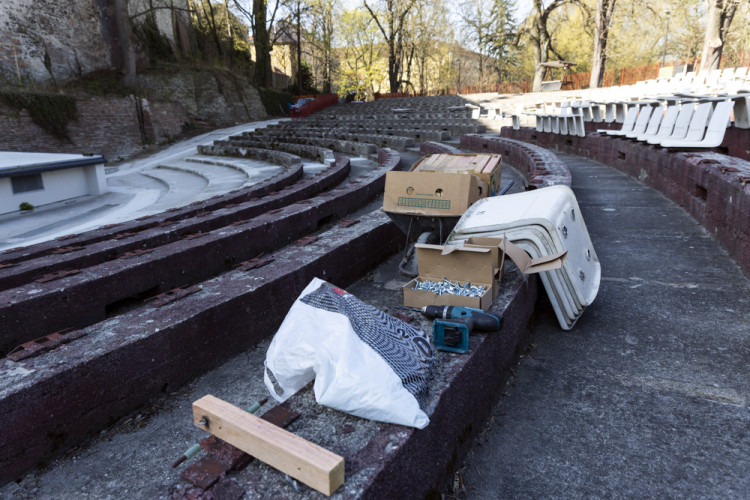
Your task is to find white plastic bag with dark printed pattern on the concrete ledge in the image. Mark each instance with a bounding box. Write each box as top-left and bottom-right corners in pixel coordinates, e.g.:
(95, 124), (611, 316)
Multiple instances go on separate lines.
(264, 278), (433, 429)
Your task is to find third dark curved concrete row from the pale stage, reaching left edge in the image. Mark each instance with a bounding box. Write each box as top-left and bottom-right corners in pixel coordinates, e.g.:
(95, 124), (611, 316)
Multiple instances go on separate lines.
(0, 154), (400, 351)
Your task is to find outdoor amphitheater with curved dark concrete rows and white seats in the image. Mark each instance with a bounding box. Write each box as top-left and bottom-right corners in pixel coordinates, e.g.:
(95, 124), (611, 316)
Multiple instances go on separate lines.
(0, 68), (750, 499)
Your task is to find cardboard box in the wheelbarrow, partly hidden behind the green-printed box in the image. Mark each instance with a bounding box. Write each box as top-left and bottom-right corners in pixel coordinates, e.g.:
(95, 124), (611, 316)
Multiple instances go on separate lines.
(409, 153), (503, 196)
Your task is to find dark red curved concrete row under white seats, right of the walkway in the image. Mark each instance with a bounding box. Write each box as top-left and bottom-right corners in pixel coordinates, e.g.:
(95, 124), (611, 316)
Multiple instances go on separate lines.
(502, 127), (750, 274)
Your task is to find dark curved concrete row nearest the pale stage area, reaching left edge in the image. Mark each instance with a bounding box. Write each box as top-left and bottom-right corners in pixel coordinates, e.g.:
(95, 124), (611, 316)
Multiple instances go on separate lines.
(0, 161), (303, 266)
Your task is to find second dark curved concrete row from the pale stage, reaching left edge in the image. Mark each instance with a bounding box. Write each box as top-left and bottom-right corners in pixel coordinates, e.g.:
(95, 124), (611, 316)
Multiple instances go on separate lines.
(0, 156), (350, 290)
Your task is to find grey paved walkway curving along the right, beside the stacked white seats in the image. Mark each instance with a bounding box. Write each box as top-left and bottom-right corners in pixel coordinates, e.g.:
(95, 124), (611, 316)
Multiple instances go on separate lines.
(462, 154), (750, 499)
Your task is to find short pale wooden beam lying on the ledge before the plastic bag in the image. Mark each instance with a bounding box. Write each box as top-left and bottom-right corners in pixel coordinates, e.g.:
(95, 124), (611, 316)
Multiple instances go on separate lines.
(193, 395), (344, 495)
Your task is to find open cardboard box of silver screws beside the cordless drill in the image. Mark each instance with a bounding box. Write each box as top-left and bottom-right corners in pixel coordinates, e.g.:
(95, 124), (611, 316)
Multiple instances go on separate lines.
(401, 243), (499, 310)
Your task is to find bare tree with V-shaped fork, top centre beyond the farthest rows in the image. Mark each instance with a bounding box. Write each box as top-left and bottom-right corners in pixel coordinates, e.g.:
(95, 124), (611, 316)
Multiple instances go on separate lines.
(364, 0), (416, 92)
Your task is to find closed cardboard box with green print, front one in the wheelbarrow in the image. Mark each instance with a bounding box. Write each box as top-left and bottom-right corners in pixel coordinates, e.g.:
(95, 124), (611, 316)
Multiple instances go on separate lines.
(383, 172), (488, 216)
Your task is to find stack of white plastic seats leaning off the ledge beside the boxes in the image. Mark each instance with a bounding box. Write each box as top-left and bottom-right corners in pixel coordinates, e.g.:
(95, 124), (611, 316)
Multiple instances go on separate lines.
(447, 186), (601, 330)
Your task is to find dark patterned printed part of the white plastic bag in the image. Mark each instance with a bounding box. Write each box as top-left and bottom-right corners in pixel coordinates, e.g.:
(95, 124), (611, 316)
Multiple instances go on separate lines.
(301, 285), (434, 407)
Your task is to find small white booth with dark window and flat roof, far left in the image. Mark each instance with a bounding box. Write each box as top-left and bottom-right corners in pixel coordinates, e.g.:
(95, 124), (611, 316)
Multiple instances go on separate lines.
(0, 151), (107, 214)
